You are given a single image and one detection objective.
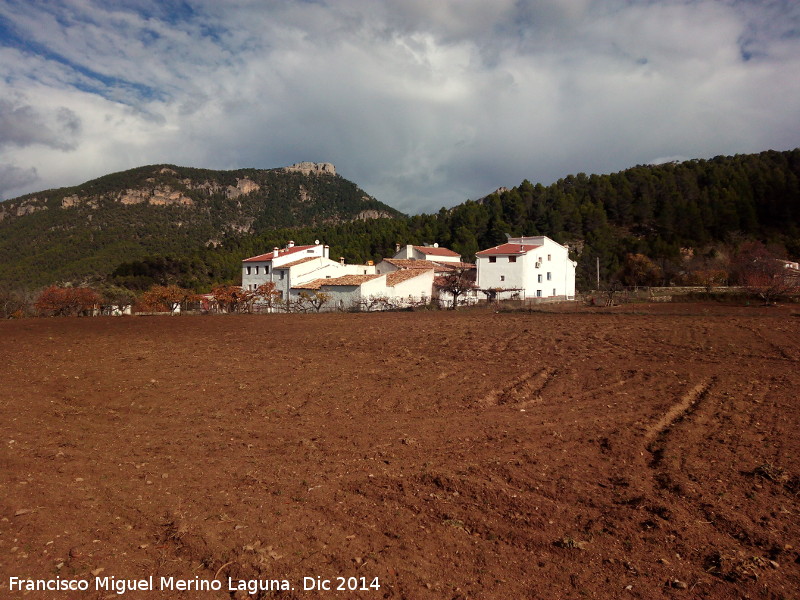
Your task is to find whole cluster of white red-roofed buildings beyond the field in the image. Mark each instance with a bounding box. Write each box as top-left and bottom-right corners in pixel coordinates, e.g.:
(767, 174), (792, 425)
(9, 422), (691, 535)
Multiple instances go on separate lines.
(234, 236), (576, 311)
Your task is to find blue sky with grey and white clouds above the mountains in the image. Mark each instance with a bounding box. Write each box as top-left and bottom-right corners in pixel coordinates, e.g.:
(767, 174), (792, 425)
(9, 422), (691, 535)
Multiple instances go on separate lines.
(0, 0), (800, 214)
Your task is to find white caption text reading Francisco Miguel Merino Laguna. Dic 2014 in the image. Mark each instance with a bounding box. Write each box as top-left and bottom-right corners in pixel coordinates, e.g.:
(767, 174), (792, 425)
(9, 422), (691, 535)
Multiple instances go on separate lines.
(8, 575), (381, 595)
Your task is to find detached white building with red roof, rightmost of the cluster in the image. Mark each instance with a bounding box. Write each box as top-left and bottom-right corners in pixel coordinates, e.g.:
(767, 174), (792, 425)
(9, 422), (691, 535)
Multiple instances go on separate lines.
(475, 235), (577, 300)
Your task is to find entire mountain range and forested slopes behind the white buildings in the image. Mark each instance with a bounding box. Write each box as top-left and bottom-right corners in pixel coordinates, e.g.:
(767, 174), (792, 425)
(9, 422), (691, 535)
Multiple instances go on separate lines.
(0, 149), (800, 291)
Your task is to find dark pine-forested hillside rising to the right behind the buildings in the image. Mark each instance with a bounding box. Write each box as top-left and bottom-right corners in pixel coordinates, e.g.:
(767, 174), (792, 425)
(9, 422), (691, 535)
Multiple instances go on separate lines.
(108, 150), (800, 289)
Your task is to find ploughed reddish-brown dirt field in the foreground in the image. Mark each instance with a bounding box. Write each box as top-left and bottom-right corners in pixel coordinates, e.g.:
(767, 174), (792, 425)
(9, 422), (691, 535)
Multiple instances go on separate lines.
(0, 304), (800, 600)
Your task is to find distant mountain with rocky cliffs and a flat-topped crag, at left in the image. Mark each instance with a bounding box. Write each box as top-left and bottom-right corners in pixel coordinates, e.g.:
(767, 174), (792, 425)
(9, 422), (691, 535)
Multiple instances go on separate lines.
(0, 163), (402, 287)
